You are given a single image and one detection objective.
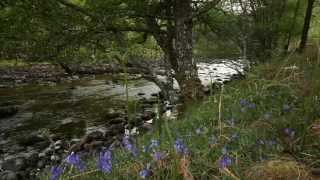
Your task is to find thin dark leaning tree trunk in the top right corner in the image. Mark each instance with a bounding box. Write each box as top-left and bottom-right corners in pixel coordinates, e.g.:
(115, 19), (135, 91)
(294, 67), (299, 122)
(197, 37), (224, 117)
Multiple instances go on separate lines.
(298, 0), (315, 53)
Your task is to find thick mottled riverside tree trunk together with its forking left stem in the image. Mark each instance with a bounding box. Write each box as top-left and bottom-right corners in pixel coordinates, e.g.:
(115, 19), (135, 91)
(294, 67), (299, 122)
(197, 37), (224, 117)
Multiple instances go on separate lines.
(146, 0), (204, 102)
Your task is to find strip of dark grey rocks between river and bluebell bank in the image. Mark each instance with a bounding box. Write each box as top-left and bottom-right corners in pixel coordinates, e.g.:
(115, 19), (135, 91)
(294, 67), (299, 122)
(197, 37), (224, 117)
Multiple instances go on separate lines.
(0, 95), (168, 179)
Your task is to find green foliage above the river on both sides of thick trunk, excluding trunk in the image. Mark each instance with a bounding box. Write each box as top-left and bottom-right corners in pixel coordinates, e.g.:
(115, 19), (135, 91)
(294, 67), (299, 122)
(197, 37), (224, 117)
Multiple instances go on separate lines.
(0, 0), (319, 64)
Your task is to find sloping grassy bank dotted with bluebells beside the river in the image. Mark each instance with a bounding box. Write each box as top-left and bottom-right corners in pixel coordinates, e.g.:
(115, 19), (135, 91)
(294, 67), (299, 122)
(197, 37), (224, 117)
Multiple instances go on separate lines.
(42, 49), (320, 180)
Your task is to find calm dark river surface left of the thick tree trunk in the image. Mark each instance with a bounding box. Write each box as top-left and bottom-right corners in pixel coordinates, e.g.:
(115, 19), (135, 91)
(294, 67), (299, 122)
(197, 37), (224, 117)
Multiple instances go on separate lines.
(0, 76), (159, 139)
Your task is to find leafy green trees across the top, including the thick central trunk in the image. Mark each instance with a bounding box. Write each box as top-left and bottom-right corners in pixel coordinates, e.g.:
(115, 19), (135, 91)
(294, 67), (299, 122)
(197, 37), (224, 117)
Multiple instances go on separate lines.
(0, 0), (313, 99)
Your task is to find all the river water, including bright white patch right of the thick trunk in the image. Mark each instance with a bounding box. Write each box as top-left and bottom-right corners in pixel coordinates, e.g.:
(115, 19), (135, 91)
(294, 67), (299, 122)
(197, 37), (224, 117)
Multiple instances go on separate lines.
(0, 60), (243, 157)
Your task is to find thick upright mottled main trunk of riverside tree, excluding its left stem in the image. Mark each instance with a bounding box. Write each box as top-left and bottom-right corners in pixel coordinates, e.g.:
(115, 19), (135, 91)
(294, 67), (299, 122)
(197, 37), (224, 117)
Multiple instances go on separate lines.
(171, 0), (203, 101)
